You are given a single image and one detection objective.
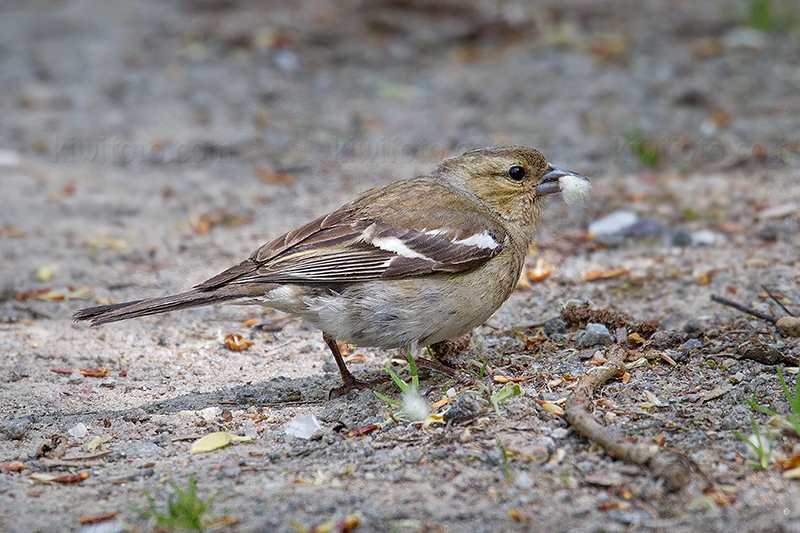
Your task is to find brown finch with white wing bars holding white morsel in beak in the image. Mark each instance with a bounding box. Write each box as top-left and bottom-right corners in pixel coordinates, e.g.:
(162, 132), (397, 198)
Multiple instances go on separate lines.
(74, 146), (589, 397)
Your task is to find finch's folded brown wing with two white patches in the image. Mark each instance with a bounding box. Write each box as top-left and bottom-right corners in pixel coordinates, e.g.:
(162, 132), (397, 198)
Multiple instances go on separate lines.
(196, 206), (507, 290)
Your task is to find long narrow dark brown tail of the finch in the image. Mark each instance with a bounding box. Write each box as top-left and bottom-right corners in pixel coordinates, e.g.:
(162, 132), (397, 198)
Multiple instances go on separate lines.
(73, 287), (247, 326)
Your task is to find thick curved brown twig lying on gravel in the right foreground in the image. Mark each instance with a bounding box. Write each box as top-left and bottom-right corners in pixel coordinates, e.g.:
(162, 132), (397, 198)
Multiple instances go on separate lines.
(564, 346), (692, 491)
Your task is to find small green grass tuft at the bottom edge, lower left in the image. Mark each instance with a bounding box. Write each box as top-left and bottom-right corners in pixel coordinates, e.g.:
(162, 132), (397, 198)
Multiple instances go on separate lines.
(133, 474), (222, 531)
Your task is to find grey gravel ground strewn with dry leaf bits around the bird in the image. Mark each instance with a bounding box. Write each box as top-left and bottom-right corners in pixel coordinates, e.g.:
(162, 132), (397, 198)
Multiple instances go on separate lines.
(0, 0), (800, 532)
